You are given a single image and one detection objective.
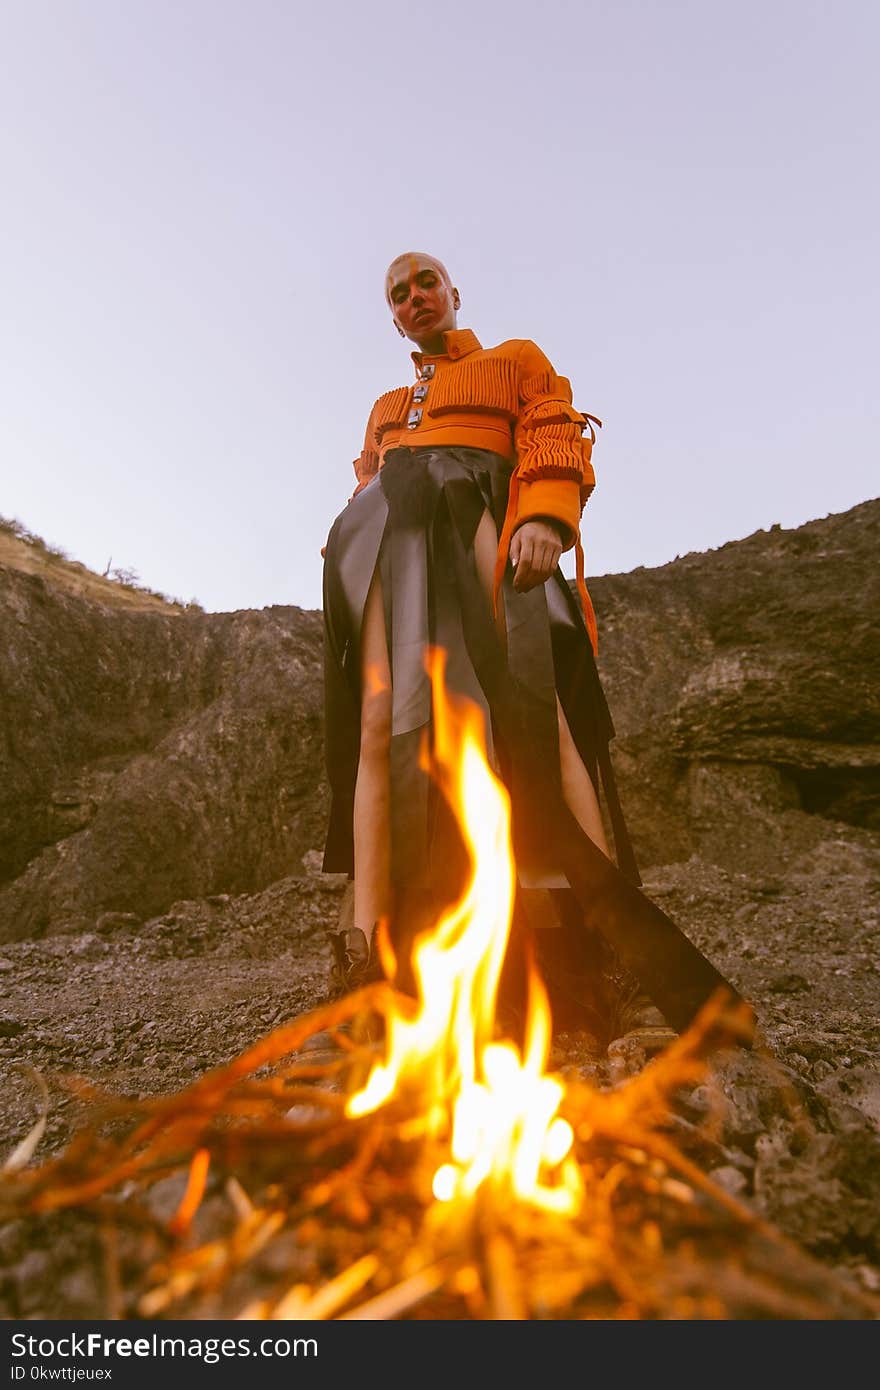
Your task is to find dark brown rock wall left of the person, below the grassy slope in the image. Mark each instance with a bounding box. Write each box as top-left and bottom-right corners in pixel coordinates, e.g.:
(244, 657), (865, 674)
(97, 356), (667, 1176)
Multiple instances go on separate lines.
(0, 558), (327, 941)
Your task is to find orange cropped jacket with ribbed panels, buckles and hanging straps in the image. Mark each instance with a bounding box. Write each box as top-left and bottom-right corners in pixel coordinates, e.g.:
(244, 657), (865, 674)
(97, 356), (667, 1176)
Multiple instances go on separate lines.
(343, 328), (601, 651)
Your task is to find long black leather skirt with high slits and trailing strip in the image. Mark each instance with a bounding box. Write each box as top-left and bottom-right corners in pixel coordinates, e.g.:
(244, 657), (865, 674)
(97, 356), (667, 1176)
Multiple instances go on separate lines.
(324, 448), (745, 1026)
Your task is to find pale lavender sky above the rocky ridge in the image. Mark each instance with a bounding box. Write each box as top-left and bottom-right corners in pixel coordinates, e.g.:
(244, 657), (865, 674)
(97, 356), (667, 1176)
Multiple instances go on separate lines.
(0, 0), (880, 610)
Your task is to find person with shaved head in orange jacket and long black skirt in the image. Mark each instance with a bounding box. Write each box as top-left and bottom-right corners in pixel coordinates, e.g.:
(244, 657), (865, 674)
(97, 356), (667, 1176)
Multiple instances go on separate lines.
(324, 252), (739, 1036)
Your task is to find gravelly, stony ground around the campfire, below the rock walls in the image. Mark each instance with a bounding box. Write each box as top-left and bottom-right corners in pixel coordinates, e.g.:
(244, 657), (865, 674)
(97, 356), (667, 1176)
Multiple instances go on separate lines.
(0, 823), (880, 1318)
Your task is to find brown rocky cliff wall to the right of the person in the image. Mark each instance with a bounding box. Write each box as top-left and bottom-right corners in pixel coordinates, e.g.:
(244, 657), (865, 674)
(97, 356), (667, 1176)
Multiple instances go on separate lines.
(591, 502), (880, 870)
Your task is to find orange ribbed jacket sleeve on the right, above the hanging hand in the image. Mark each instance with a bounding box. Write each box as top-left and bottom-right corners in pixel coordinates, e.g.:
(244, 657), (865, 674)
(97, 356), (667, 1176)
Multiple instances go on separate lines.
(510, 342), (595, 550)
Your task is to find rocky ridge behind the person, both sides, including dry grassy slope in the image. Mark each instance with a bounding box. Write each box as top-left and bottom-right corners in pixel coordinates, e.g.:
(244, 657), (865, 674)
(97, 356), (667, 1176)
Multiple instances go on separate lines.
(0, 502), (880, 941)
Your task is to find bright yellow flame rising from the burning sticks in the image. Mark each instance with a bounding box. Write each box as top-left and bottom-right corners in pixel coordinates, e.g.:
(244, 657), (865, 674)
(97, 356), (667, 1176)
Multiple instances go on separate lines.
(346, 648), (581, 1212)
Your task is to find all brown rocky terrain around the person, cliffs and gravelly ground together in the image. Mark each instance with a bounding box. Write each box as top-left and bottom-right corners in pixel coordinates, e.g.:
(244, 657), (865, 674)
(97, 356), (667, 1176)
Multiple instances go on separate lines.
(0, 500), (880, 1318)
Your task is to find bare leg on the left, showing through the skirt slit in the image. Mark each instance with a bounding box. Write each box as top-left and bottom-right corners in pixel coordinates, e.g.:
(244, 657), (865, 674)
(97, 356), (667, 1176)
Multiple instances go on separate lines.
(353, 569), (391, 941)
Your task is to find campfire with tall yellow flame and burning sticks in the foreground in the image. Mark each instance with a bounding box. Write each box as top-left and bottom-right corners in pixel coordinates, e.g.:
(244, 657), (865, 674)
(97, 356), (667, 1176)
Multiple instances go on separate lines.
(0, 651), (856, 1319)
